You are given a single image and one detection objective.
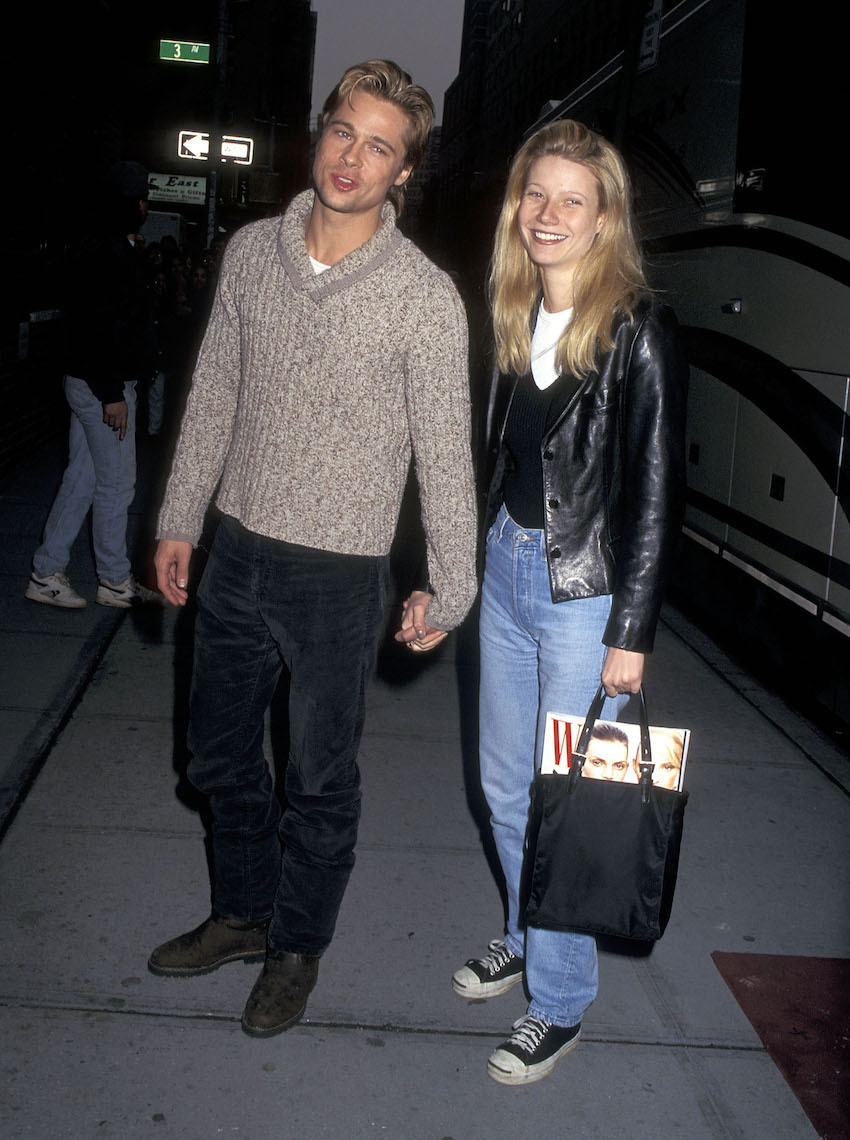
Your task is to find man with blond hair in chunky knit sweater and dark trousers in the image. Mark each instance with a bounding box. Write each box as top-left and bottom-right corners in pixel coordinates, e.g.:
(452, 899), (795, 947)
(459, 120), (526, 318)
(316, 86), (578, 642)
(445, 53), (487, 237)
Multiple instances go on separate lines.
(148, 60), (476, 1036)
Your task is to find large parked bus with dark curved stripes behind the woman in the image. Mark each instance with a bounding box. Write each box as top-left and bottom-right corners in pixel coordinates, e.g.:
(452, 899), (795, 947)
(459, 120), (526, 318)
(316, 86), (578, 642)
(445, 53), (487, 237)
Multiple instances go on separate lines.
(534, 0), (850, 724)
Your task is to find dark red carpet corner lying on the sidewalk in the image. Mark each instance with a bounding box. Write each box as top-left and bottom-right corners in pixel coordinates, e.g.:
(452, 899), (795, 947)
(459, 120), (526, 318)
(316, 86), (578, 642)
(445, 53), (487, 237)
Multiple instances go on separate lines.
(711, 951), (850, 1140)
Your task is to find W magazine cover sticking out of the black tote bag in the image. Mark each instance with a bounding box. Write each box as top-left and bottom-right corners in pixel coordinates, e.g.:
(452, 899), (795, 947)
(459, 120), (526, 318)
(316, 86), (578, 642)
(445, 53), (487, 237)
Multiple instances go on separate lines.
(540, 713), (690, 791)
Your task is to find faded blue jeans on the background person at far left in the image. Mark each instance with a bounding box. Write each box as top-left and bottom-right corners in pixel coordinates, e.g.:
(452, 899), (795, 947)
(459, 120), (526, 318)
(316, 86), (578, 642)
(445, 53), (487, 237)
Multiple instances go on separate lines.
(33, 376), (136, 583)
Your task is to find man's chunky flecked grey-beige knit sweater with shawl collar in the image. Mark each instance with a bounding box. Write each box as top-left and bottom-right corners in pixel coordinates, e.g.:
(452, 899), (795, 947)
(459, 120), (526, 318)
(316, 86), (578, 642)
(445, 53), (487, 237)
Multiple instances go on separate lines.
(157, 190), (476, 629)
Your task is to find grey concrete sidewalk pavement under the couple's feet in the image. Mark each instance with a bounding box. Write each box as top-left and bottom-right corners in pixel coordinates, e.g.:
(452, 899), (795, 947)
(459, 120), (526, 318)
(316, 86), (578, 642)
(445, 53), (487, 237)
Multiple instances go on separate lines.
(0, 433), (850, 1140)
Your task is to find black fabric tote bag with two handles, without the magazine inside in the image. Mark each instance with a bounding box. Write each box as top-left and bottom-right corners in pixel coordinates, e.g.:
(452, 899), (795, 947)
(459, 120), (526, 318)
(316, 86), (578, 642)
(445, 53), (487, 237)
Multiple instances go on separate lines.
(525, 686), (687, 942)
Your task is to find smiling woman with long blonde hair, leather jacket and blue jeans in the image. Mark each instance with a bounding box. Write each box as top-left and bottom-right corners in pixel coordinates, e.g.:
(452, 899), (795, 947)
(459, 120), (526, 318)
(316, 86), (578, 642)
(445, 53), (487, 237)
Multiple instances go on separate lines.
(452, 121), (687, 1084)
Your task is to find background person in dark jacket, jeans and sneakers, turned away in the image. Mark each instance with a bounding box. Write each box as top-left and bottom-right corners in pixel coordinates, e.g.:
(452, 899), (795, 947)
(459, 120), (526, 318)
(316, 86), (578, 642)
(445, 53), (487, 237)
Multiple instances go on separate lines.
(26, 162), (160, 610)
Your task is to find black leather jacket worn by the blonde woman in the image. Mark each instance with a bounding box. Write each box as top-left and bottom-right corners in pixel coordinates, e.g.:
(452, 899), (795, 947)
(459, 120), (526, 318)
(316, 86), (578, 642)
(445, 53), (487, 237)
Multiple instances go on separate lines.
(484, 302), (688, 652)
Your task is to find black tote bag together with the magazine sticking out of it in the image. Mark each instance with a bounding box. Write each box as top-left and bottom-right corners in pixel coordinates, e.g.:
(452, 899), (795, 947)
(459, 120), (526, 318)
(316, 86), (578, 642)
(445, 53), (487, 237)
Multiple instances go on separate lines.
(525, 686), (689, 942)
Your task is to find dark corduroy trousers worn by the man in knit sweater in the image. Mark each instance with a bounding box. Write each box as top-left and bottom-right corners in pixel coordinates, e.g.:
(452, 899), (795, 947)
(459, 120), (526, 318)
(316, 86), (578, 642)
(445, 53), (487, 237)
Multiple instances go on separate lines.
(188, 518), (387, 956)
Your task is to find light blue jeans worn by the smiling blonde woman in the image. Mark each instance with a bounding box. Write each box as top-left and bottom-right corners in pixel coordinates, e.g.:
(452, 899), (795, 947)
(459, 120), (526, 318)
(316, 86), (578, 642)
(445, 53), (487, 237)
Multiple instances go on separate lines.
(479, 506), (626, 1026)
